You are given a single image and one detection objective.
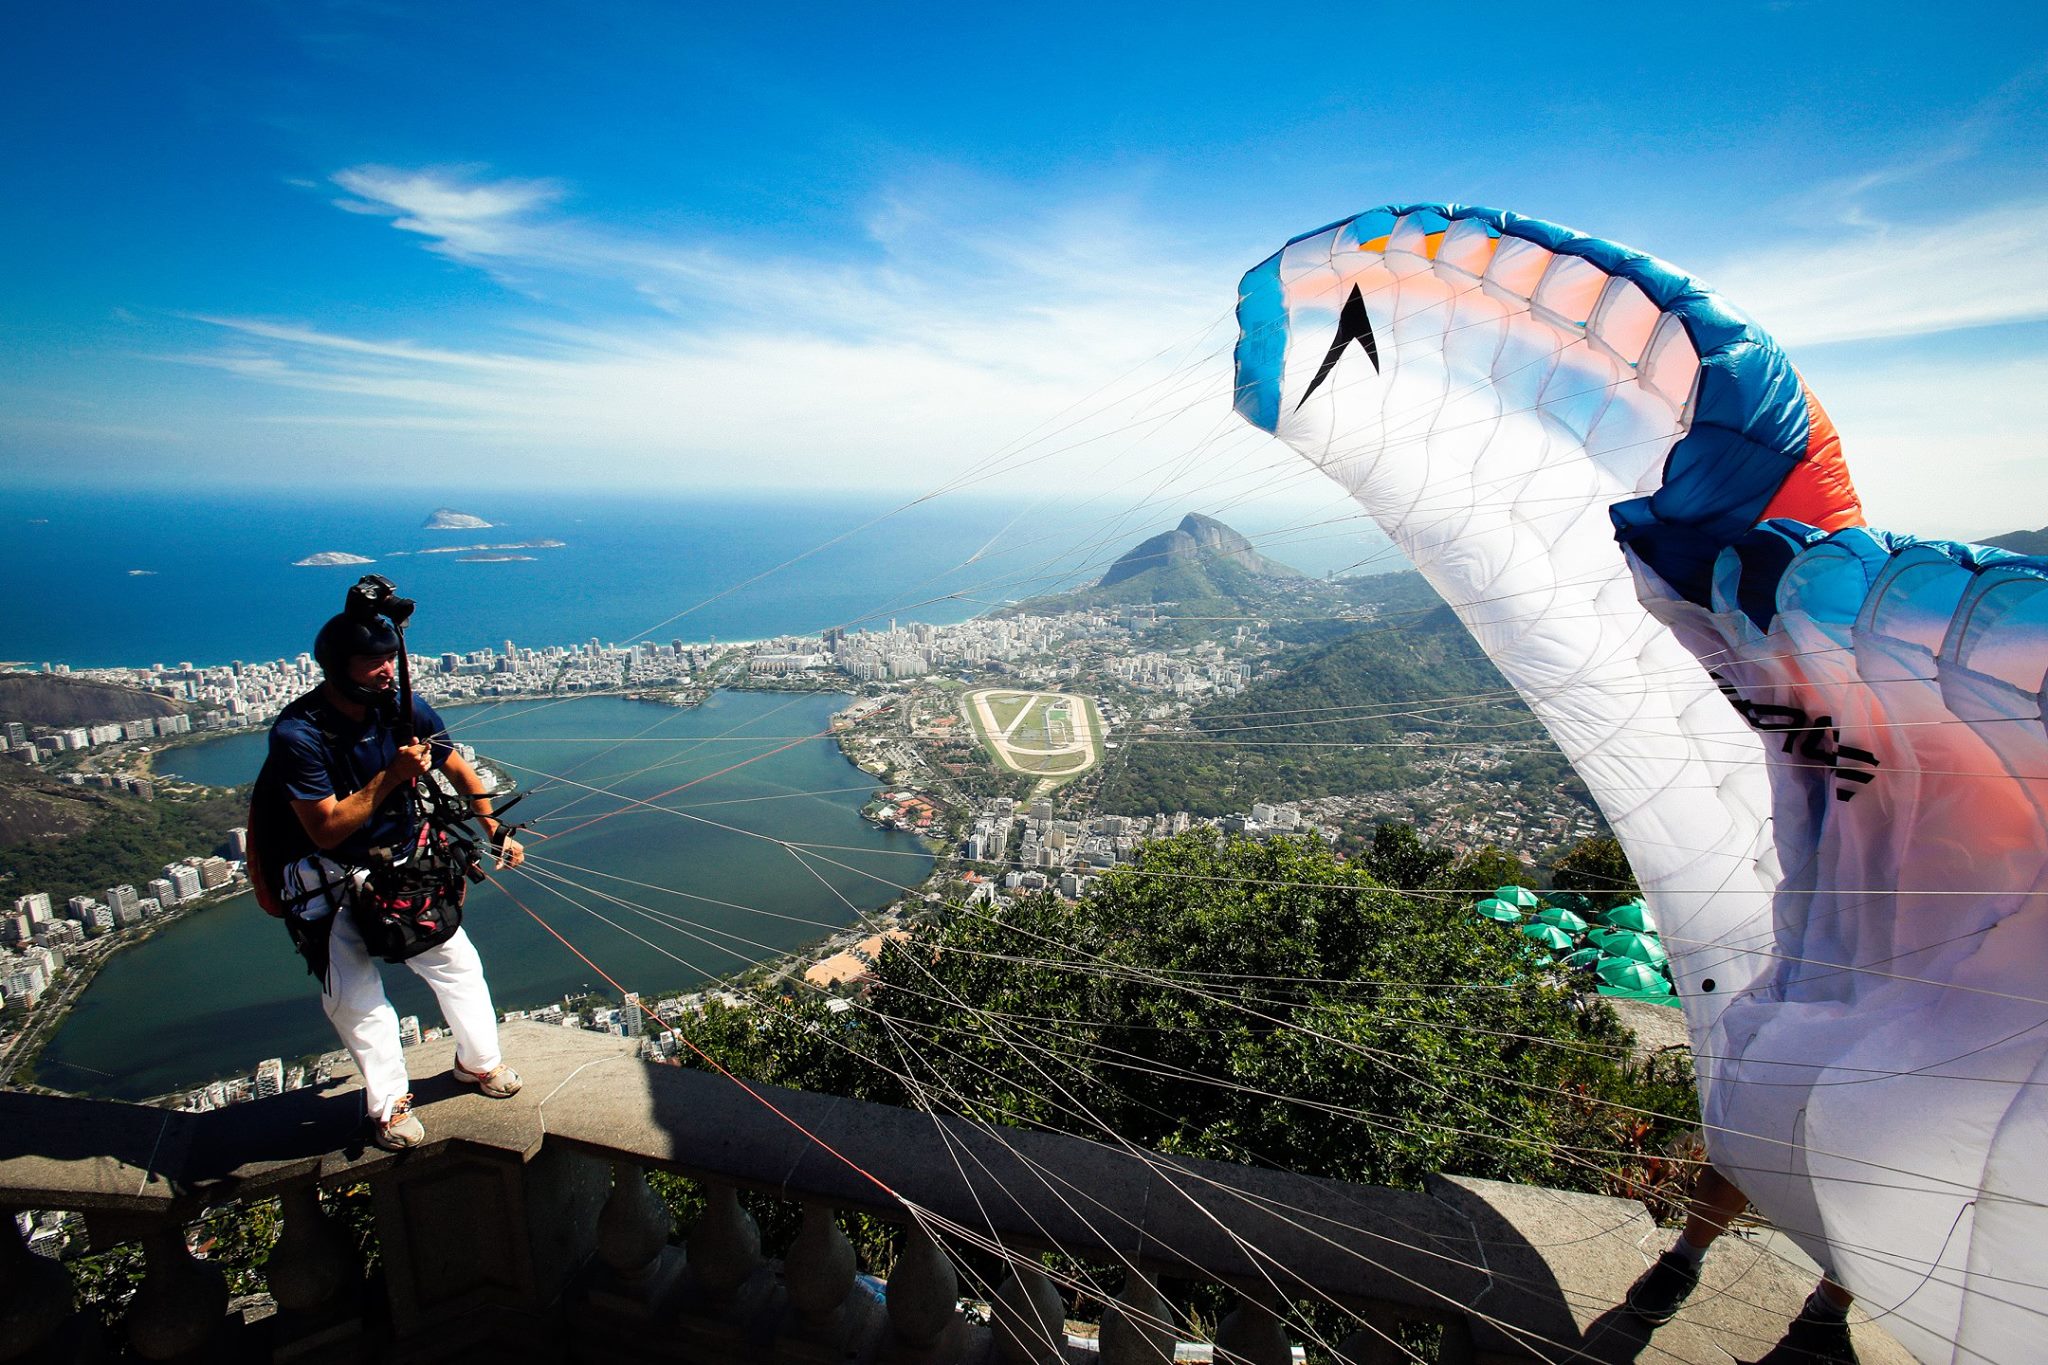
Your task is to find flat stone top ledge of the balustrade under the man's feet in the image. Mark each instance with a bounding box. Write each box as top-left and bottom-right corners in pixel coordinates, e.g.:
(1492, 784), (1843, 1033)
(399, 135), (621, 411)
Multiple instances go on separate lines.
(0, 1023), (1911, 1365)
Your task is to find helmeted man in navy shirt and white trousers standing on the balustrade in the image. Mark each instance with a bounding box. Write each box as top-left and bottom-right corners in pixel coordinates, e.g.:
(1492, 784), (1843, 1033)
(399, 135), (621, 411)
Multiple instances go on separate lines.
(270, 604), (526, 1152)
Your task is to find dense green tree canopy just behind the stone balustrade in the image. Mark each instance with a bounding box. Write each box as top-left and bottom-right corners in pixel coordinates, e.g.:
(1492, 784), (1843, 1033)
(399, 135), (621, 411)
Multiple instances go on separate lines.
(692, 833), (1692, 1189)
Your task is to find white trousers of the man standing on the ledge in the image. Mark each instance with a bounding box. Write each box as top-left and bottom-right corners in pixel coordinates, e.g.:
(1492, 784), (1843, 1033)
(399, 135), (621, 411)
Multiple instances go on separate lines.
(285, 857), (504, 1124)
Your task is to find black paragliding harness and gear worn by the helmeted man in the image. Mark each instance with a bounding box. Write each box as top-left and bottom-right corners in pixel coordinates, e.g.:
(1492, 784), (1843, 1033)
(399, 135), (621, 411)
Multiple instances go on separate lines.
(248, 575), (520, 984)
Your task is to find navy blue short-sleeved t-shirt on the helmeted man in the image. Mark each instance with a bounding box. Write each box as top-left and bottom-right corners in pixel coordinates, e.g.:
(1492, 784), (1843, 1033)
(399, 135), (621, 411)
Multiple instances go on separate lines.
(270, 688), (455, 864)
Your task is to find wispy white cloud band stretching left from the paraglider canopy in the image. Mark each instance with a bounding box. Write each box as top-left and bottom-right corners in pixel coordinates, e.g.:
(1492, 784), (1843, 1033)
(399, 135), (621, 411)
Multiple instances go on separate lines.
(160, 166), (1235, 485)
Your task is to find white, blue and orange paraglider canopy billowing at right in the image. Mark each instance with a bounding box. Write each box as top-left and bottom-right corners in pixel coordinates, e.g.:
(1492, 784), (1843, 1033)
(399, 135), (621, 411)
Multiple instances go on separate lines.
(1235, 203), (2048, 1361)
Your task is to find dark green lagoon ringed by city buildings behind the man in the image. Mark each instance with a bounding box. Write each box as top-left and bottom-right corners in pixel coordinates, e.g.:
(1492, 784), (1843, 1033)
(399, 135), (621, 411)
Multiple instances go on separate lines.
(37, 692), (932, 1099)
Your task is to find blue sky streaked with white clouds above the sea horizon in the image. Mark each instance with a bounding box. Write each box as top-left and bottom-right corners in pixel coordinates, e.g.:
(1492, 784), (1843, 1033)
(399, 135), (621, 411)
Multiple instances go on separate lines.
(0, 0), (2048, 534)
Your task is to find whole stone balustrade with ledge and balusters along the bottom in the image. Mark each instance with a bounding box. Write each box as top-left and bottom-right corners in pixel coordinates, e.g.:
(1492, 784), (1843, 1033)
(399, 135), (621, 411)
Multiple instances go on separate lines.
(0, 1025), (1907, 1365)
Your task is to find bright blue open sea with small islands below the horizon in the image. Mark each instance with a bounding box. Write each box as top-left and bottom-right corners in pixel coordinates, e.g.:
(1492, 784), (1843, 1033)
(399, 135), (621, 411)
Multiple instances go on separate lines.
(0, 487), (1073, 667)
